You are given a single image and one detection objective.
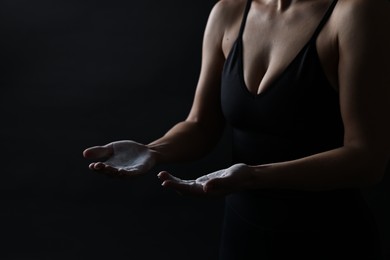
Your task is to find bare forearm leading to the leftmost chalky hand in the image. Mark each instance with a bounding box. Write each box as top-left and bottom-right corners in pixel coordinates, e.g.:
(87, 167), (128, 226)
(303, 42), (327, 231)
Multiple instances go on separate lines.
(147, 121), (223, 163)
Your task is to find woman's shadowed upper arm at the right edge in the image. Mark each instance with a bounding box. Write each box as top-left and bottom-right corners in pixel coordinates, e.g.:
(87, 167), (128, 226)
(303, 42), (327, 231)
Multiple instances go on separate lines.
(338, 0), (390, 171)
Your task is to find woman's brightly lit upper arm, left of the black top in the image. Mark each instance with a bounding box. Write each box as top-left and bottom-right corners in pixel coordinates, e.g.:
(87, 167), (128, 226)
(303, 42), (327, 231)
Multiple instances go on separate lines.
(187, 2), (230, 134)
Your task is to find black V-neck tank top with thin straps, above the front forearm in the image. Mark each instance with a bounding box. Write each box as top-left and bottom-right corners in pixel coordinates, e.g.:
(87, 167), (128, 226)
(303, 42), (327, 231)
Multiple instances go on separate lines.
(221, 0), (343, 165)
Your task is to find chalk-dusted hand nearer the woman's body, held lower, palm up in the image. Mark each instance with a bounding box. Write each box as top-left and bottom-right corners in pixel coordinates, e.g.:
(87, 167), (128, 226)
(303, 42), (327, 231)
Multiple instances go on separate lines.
(157, 163), (254, 196)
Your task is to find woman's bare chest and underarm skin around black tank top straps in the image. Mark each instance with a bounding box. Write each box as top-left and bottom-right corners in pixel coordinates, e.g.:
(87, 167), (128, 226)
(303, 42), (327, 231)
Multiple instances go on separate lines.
(222, 0), (338, 94)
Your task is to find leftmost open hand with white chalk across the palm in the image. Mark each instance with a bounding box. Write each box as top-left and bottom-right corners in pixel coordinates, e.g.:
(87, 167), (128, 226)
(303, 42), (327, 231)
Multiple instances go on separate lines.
(83, 141), (156, 176)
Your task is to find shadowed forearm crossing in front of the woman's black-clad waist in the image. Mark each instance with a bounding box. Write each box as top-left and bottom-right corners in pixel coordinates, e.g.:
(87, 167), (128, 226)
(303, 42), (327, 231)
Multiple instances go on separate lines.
(251, 147), (387, 191)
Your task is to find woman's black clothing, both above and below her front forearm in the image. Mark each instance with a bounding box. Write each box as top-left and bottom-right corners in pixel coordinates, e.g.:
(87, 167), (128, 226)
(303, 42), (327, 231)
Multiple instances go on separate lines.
(220, 0), (384, 259)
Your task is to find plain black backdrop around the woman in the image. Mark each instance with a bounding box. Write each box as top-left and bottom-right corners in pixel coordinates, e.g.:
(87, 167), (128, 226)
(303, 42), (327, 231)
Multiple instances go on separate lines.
(0, 0), (390, 260)
